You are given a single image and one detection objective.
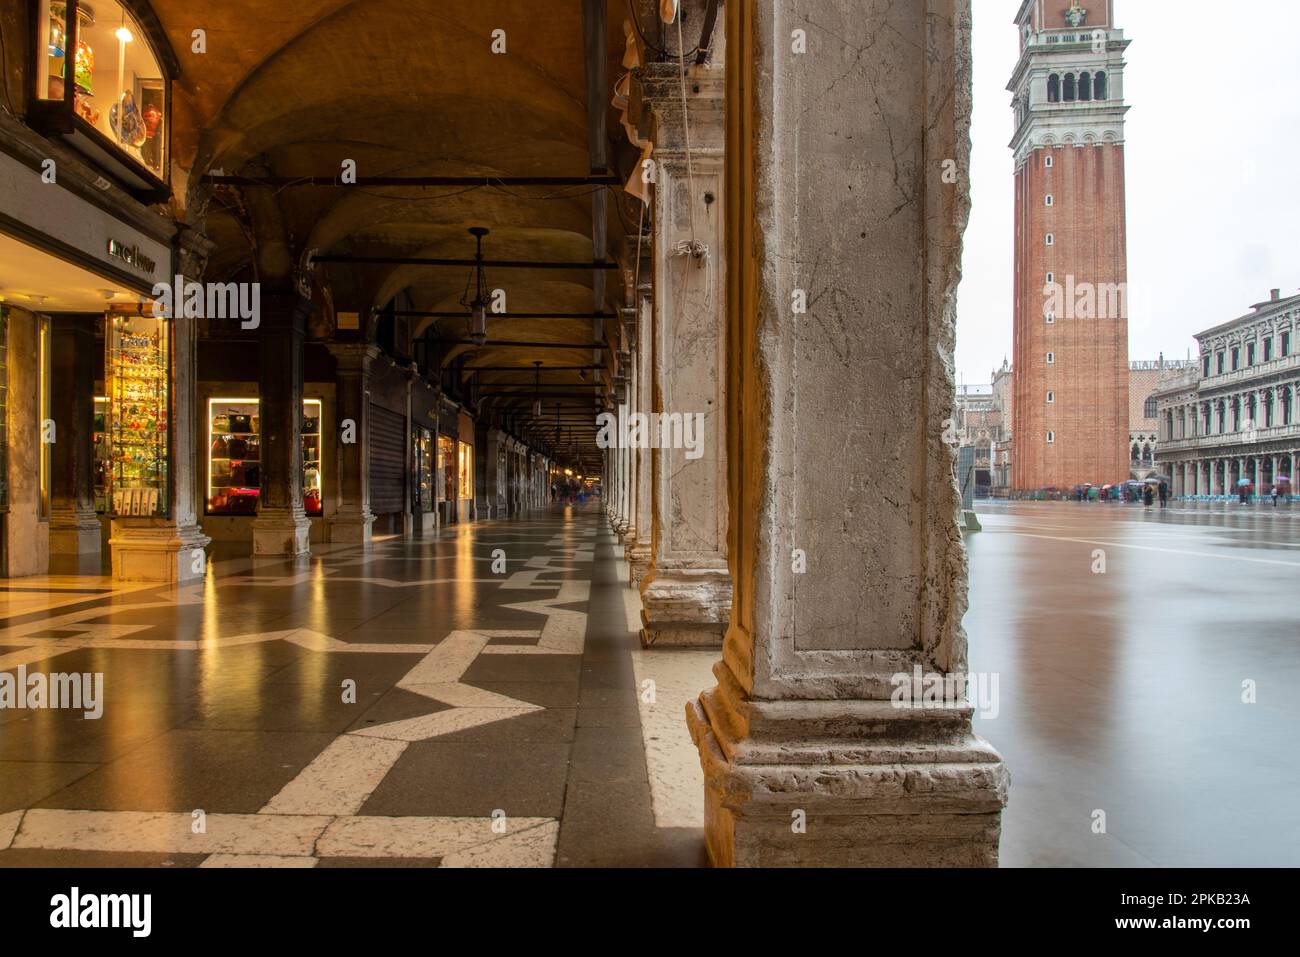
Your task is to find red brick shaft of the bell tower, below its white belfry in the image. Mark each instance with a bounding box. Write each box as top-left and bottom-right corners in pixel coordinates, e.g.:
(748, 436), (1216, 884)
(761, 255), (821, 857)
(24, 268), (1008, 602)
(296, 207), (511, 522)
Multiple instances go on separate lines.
(1011, 144), (1128, 492)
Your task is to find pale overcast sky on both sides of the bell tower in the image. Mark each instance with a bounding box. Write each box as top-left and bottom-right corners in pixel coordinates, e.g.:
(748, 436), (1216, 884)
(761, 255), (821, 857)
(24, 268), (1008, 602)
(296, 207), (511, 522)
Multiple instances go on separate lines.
(957, 0), (1300, 385)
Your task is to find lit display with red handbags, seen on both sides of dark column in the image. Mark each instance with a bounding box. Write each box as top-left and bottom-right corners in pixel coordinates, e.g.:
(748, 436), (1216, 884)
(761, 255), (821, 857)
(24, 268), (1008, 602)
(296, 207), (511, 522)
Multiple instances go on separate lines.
(203, 398), (324, 516)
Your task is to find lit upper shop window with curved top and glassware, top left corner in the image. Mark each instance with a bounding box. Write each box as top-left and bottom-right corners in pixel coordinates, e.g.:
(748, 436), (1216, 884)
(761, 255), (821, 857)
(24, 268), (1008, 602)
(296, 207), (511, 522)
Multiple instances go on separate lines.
(36, 0), (168, 179)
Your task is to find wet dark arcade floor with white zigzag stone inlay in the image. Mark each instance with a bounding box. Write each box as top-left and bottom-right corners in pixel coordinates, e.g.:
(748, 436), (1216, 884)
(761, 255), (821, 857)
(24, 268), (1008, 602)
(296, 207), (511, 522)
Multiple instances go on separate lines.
(0, 503), (705, 866)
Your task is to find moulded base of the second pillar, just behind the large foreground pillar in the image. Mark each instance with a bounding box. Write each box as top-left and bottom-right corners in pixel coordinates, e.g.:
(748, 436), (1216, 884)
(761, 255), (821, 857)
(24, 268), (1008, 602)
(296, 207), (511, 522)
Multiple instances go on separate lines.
(641, 568), (732, 648)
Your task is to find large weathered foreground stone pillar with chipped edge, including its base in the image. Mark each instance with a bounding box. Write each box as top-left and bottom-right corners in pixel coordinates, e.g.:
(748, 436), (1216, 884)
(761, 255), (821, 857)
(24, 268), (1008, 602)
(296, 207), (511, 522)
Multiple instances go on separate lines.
(688, 0), (1009, 867)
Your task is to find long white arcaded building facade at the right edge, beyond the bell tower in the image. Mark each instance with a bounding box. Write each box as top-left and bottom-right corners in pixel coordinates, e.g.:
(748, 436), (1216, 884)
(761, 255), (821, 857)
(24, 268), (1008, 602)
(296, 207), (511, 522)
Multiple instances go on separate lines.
(1154, 290), (1300, 497)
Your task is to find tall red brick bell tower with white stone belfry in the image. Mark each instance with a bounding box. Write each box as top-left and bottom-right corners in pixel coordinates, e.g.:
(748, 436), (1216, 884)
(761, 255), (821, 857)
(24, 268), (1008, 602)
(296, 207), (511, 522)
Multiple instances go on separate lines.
(1008, 0), (1128, 492)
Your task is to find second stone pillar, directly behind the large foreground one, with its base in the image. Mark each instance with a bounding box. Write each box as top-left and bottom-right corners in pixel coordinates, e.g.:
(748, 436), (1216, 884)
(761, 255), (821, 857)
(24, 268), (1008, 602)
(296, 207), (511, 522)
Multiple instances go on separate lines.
(640, 35), (733, 646)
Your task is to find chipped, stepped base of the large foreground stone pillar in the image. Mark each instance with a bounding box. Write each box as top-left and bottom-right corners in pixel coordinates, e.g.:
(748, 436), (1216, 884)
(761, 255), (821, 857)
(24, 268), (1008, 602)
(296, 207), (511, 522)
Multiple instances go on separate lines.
(686, 663), (1010, 867)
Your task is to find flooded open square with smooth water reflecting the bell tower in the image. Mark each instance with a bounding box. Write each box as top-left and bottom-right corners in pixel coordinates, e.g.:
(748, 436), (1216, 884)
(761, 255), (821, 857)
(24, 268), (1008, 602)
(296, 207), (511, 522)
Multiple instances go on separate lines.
(965, 503), (1300, 866)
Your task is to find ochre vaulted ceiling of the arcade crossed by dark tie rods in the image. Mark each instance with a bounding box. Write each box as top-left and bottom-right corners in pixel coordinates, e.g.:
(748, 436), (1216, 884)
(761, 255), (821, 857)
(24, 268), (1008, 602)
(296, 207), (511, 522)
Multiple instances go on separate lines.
(152, 0), (655, 468)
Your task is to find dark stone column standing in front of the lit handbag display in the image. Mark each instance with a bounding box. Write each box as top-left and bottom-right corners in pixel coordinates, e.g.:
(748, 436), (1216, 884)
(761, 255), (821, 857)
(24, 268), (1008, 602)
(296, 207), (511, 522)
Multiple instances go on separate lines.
(252, 291), (311, 558)
